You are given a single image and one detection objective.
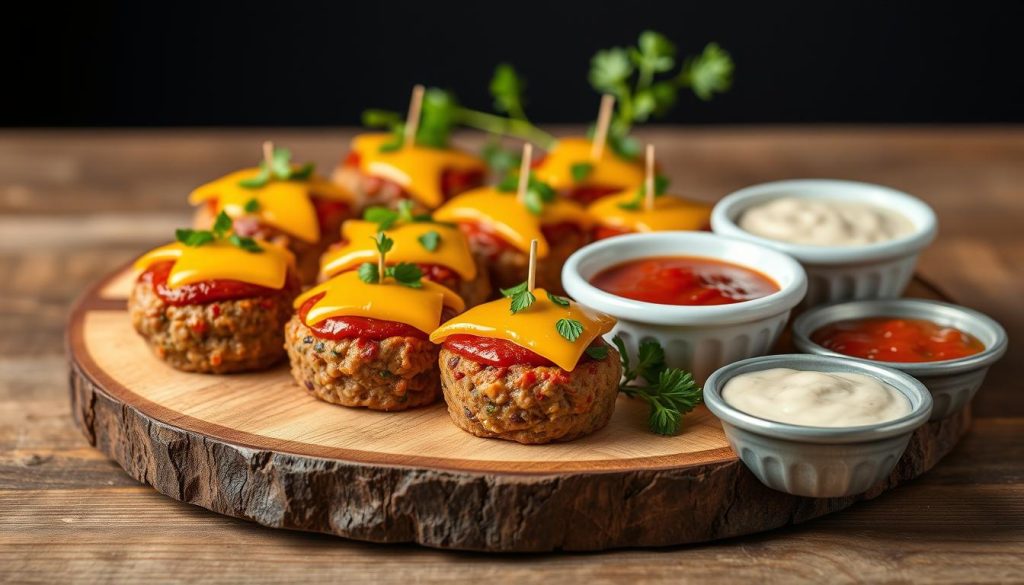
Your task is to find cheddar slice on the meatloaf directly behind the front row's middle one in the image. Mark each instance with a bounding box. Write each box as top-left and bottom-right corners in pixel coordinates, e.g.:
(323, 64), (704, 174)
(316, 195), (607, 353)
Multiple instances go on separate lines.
(321, 219), (476, 281)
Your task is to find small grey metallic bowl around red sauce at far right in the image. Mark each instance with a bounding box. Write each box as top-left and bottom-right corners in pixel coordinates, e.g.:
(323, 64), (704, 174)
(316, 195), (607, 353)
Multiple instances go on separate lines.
(793, 298), (1008, 420)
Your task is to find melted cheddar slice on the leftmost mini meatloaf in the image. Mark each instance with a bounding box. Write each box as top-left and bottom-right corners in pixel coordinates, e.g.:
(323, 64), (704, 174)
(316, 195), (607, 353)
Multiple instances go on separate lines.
(134, 241), (295, 290)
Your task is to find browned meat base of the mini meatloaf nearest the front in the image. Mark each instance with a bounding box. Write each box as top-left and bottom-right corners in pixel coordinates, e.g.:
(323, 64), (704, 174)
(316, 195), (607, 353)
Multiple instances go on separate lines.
(439, 347), (622, 445)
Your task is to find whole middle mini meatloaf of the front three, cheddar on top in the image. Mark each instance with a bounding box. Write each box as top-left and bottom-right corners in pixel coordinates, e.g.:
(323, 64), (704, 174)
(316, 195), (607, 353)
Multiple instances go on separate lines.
(285, 238), (465, 411)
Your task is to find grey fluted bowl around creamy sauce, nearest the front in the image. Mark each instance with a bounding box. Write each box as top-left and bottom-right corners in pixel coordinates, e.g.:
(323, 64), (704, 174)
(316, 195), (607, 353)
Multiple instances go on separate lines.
(703, 353), (932, 498)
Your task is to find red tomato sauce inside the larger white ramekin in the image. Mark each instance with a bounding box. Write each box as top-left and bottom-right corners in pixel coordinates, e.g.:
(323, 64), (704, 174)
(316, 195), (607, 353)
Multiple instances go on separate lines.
(590, 256), (779, 305)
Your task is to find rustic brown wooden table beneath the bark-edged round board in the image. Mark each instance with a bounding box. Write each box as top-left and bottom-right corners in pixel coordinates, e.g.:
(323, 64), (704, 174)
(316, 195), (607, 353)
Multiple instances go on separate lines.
(0, 127), (1024, 583)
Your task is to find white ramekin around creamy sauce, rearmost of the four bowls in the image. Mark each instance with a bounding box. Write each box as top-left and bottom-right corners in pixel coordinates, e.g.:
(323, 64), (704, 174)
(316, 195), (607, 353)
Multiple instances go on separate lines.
(711, 179), (938, 306)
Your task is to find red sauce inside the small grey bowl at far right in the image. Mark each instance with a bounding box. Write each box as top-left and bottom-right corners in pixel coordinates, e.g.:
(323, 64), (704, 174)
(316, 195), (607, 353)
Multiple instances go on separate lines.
(811, 317), (985, 363)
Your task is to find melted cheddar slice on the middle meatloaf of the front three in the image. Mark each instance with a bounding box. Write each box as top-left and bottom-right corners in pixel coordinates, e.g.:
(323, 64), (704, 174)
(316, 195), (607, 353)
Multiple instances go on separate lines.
(294, 271), (466, 333)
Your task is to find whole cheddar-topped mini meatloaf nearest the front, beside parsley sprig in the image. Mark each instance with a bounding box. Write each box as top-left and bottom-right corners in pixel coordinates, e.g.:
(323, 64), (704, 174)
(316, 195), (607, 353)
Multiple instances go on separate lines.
(430, 280), (622, 444)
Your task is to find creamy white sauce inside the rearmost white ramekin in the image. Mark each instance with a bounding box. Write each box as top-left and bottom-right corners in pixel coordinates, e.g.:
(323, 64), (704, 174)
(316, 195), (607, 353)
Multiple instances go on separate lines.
(739, 197), (914, 246)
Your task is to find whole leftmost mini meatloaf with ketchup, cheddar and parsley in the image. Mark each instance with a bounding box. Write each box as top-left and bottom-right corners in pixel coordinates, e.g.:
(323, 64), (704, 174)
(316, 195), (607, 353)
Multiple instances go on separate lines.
(128, 216), (299, 374)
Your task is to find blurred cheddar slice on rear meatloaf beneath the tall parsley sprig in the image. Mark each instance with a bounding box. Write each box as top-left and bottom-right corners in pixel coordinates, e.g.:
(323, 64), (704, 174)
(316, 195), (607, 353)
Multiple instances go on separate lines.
(534, 137), (644, 191)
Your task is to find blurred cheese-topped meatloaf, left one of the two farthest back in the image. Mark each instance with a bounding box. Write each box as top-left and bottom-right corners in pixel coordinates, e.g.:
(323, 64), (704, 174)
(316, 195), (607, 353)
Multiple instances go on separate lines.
(332, 132), (487, 210)
